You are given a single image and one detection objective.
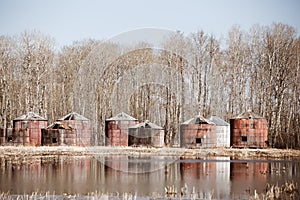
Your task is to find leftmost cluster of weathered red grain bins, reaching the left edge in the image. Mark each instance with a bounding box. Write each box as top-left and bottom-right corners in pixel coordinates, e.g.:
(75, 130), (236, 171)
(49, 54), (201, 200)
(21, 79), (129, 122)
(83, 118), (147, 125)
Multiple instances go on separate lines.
(0, 112), (92, 146)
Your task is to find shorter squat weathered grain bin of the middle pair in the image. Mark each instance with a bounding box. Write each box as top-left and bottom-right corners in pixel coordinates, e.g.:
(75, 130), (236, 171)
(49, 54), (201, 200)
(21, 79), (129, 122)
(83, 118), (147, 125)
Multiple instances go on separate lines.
(128, 121), (164, 147)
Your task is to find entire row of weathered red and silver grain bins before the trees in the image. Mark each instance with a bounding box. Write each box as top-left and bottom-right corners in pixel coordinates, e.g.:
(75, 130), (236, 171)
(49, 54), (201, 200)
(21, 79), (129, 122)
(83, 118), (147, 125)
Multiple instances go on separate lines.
(0, 110), (268, 148)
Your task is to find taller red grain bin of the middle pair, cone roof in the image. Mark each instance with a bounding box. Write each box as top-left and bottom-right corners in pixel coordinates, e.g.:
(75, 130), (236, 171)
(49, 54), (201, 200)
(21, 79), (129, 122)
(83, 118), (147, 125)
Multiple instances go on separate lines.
(105, 112), (138, 146)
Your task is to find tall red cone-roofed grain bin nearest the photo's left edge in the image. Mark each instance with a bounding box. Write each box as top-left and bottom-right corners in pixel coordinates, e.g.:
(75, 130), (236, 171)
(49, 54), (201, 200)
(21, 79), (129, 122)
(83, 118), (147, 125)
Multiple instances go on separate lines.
(12, 112), (48, 146)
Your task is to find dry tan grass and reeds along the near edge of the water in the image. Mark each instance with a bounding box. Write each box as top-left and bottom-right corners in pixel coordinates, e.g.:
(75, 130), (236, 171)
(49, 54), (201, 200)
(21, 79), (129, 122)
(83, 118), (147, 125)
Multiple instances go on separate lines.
(0, 181), (300, 200)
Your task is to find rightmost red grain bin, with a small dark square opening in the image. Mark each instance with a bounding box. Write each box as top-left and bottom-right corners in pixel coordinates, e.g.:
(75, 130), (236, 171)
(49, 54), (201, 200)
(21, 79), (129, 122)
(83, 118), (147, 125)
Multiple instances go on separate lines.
(230, 110), (268, 148)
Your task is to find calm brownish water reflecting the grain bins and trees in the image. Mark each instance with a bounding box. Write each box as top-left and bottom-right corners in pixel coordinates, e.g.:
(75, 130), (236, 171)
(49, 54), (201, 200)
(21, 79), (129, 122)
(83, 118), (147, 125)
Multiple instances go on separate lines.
(0, 156), (300, 199)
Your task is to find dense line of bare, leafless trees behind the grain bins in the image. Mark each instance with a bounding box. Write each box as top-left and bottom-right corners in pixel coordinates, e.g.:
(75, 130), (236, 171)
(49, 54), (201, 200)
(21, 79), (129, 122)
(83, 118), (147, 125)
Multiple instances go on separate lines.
(0, 24), (300, 148)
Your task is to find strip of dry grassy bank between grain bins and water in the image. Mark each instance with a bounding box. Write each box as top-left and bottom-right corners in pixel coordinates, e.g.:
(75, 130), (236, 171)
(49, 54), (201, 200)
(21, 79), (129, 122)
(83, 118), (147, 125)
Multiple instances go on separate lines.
(0, 146), (300, 159)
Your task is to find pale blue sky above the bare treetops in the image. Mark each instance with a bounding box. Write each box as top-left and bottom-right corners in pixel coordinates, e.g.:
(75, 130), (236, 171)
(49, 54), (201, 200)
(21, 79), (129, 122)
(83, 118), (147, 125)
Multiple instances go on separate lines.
(0, 0), (300, 46)
